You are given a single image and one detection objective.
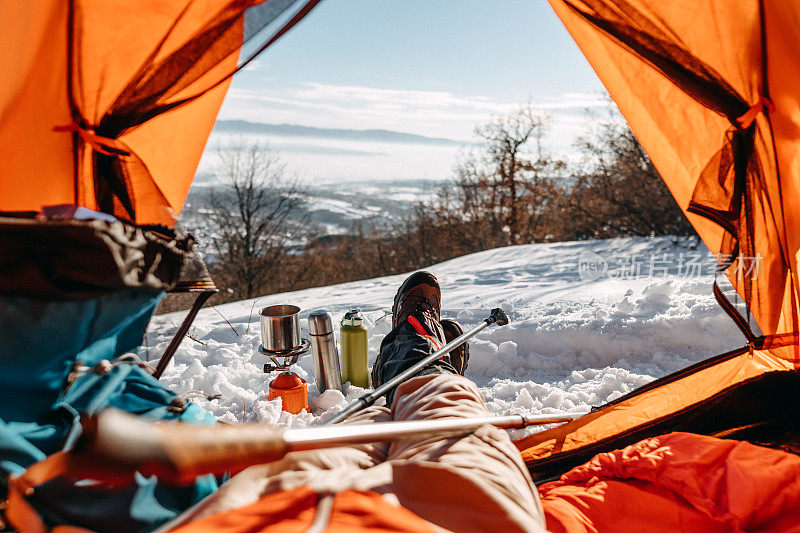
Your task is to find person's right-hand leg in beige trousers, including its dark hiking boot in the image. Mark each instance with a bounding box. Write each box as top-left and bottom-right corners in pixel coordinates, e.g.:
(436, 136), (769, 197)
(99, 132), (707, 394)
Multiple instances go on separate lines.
(366, 272), (545, 531)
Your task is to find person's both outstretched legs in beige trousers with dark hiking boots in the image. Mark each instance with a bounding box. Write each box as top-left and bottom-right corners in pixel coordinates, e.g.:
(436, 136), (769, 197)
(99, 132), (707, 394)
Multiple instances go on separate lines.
(170, 272), (544, 531)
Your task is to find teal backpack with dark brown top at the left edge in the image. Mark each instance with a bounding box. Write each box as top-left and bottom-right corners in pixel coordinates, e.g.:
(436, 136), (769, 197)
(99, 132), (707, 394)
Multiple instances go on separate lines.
(0, 218), (217, 532)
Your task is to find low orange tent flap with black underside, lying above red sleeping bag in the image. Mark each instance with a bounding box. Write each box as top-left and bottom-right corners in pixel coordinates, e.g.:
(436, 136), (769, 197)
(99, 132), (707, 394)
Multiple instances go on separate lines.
(515, 346), (800, 483)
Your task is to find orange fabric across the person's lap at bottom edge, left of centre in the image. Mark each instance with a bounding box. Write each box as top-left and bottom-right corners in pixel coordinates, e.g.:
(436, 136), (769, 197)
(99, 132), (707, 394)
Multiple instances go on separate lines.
(167, 487), (440, 533)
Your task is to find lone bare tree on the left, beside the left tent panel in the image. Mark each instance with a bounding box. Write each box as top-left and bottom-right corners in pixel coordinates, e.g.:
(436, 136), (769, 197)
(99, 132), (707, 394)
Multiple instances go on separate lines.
(209, 141), (306, 298)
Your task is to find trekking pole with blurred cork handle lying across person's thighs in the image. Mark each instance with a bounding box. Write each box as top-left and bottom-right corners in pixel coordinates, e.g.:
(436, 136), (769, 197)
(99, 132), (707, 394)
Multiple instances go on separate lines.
(72, 409), (586, 483)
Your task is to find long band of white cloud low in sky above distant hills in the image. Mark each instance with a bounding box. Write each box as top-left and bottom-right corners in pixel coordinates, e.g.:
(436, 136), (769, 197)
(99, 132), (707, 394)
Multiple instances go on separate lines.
(220, 83), (608, 155)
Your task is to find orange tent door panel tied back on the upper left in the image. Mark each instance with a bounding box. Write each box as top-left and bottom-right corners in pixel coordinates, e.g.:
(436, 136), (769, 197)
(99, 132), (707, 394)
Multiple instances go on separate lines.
(0, 0), (320, 227)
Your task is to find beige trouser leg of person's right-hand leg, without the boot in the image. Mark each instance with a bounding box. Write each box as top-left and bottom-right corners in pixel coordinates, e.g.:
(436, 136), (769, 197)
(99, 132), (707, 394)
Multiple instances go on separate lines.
(379, 375), (545, 531)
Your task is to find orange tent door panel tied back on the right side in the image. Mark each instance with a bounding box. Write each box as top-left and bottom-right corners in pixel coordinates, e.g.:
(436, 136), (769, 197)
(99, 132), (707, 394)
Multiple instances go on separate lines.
(549, 0), (800, 365)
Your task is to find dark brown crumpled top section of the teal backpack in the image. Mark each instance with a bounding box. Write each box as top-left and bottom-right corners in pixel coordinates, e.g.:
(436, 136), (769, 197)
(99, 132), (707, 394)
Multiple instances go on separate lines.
(0, 217), (192, 300)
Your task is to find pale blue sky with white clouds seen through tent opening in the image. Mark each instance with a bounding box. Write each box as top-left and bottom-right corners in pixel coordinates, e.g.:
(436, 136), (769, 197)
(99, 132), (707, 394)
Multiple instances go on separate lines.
(203, 0), (606, 179)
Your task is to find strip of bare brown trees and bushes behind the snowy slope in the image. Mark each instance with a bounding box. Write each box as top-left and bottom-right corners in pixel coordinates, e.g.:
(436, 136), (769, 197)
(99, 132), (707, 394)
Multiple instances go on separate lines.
(162, 100), (696, 311)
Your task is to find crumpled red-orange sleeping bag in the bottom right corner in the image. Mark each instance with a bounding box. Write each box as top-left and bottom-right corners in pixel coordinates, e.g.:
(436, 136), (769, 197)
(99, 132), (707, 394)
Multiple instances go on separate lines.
(540, 433), (800, 533)
